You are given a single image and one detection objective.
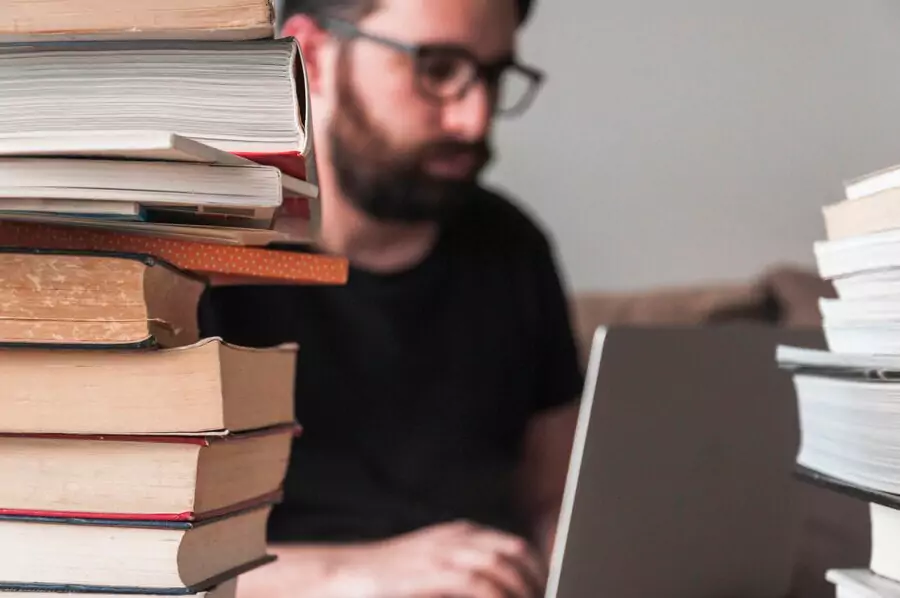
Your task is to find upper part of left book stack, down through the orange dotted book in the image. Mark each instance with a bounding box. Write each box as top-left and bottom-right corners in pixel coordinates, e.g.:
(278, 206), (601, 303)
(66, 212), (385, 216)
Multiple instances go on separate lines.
(0, 0), (346, 283)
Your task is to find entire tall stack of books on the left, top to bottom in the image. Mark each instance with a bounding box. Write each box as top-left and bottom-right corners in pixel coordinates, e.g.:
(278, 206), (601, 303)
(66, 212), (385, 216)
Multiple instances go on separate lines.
(0, 0), (347, 598)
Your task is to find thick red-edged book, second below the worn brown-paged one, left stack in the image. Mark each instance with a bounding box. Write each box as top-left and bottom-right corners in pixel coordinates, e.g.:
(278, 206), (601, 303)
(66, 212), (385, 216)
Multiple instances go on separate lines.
(0, 424), (299, 521)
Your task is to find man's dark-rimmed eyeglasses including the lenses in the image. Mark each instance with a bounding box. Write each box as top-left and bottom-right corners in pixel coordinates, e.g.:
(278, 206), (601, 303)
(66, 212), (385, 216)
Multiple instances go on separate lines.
(319, 18), (544, 116)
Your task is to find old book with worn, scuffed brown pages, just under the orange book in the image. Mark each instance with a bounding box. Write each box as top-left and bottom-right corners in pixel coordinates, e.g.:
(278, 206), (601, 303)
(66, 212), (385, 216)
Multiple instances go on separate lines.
(0, 250), (206, 349)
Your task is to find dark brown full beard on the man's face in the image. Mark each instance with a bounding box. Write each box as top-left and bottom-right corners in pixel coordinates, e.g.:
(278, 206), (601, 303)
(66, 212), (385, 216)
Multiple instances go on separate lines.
(328, 47), (491, 223)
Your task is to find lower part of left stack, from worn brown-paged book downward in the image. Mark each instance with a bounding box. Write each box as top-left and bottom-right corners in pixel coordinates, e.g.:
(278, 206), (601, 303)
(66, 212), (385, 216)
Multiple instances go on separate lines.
(0, 250), (298, 598)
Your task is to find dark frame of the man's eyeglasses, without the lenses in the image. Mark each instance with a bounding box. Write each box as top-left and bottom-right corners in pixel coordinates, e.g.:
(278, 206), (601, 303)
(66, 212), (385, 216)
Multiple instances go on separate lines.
(318, 17), (546, 116)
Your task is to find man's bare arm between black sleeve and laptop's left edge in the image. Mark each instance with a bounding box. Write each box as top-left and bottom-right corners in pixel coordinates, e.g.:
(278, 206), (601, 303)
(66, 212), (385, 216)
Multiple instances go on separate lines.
(520, 402), (578, 562)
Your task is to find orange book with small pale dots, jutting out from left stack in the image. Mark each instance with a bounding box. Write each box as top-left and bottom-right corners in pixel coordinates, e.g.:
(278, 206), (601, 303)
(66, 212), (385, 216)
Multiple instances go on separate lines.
(0, 221), (349, 285)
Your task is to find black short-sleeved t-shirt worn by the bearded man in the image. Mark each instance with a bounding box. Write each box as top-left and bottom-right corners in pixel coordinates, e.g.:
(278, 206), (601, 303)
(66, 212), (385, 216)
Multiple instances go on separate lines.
(200, 191), (582, 542)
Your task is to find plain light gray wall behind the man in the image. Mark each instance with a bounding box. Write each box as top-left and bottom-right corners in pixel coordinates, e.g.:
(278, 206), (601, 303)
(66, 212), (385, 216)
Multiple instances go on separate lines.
(489, 0), (900, 290)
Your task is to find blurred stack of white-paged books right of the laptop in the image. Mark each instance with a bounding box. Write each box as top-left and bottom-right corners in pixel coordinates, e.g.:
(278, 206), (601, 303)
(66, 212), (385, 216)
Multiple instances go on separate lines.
(777, 161), (900, 598)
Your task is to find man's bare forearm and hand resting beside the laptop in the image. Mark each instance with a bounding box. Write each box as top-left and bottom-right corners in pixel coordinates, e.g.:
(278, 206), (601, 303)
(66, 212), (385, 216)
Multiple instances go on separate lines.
(238, 523), (546, 598)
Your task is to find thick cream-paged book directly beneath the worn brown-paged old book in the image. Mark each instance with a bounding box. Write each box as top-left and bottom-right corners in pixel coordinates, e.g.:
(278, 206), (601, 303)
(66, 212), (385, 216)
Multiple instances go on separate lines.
(0, 338), (298, 436)
